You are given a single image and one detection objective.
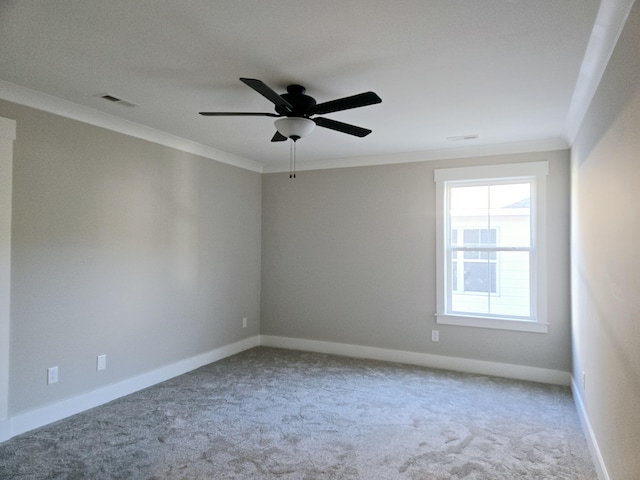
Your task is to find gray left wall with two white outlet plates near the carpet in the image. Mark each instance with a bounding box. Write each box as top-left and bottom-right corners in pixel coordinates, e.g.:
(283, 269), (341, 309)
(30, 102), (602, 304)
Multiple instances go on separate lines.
(0, 101), (261, 415)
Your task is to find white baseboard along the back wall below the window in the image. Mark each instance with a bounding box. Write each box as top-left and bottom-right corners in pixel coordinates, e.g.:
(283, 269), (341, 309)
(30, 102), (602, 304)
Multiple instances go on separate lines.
(260, 335), (571, 386)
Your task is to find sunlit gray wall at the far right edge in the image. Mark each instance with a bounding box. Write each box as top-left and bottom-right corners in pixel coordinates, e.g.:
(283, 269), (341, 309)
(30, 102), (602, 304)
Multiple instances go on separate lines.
(572, 2), (640, 480)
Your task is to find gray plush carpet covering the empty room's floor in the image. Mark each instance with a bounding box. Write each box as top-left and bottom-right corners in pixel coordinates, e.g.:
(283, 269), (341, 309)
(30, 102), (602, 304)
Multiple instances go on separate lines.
(0, 347), (597, 480)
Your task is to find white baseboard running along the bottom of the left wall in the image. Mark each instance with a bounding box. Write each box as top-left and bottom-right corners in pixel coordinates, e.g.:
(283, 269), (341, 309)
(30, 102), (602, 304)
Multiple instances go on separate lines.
(0, 335), (260, 442)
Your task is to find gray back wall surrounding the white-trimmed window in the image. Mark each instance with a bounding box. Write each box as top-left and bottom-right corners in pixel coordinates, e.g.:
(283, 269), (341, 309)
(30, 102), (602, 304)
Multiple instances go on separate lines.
(261, 151), (571, 372)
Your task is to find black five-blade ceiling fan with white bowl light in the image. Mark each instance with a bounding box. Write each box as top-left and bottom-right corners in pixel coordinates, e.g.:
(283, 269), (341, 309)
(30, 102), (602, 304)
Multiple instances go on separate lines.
(200, 78), (382, 142)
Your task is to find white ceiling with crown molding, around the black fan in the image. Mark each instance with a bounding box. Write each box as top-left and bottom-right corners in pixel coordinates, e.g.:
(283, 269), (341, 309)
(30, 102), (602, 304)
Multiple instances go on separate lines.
(0, 0), (633, 171)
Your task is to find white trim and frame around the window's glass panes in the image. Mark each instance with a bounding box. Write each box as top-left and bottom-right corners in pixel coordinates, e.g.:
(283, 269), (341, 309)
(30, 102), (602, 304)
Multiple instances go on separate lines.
(434, 161), (549, 333)
